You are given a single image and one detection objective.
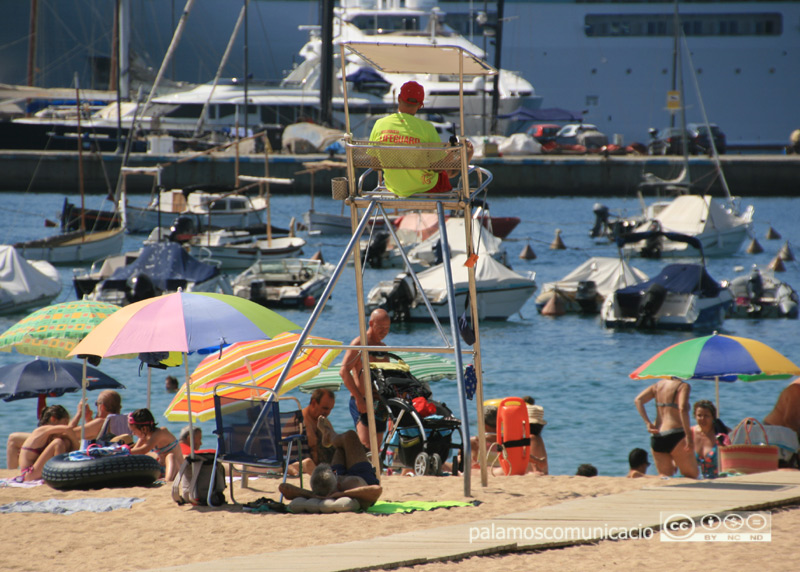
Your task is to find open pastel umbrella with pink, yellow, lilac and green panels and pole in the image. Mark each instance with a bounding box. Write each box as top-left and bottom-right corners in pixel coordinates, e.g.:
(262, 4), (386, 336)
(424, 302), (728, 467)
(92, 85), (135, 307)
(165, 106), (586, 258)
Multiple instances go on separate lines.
(69, 291), (300, 450)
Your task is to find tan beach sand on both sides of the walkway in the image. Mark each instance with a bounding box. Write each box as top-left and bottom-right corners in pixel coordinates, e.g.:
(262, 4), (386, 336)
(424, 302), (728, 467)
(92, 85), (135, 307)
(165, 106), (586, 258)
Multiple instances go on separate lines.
(0, 470), (800, 572)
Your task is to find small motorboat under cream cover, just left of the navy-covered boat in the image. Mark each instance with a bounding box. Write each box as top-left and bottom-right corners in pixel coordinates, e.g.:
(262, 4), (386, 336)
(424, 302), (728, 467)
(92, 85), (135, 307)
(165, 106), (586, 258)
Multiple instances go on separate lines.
(536, 256), (648, 314)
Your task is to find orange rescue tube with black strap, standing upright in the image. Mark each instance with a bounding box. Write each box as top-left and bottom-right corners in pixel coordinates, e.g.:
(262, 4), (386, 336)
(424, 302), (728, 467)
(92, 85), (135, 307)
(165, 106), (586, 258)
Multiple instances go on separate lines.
(497, 397), (531, 475)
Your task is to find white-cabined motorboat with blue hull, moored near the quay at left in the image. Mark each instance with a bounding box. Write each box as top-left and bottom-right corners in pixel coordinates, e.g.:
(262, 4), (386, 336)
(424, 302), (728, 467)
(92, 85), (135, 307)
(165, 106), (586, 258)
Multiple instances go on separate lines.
(125, 189), (268, 233)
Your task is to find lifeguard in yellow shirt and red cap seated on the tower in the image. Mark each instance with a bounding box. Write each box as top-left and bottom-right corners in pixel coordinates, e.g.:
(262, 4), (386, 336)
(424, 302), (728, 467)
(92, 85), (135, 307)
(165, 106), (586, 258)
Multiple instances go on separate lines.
(369, 81), (473, 197)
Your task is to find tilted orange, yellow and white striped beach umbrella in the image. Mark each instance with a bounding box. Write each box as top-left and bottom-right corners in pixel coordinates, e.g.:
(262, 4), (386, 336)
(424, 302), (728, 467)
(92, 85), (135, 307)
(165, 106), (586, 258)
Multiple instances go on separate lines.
(164, 334), (342, 421)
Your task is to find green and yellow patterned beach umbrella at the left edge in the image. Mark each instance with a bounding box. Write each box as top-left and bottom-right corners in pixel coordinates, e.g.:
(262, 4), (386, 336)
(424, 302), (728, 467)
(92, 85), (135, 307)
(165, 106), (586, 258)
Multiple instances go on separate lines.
(0, 300), (120, 359)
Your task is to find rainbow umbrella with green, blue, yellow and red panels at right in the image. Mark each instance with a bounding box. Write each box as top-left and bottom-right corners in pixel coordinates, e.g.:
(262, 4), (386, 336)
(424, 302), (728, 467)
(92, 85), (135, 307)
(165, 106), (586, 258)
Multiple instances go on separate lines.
(630, 332), (800, 413)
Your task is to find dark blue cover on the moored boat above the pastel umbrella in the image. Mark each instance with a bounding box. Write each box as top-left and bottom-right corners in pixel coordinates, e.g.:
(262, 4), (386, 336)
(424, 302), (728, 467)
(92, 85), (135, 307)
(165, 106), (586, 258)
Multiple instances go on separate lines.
(110, 242), (219, 290)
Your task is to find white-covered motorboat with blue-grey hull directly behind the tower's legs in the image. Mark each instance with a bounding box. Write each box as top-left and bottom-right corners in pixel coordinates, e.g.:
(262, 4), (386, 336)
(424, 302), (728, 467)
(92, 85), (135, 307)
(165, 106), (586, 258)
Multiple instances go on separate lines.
(366, 253), (537, 321)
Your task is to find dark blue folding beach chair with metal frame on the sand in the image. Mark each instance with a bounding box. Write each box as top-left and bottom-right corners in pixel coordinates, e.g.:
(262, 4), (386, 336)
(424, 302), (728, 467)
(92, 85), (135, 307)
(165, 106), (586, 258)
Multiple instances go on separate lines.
(212, 383), (307, 503)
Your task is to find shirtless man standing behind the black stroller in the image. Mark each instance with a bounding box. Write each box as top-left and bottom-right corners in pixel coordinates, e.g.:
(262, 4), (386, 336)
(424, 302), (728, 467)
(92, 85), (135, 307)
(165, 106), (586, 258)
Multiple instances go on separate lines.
(339, 308), (392, 449)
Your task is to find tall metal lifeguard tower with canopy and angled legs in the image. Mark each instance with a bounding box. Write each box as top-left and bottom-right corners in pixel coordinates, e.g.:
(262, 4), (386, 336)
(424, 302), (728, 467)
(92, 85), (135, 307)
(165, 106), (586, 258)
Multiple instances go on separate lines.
(276, 42), (497, 496)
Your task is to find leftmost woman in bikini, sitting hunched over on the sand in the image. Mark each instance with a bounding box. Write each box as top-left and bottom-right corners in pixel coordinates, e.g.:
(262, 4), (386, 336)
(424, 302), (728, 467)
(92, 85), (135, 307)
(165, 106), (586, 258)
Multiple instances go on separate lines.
(19, 405), (78, 481)
